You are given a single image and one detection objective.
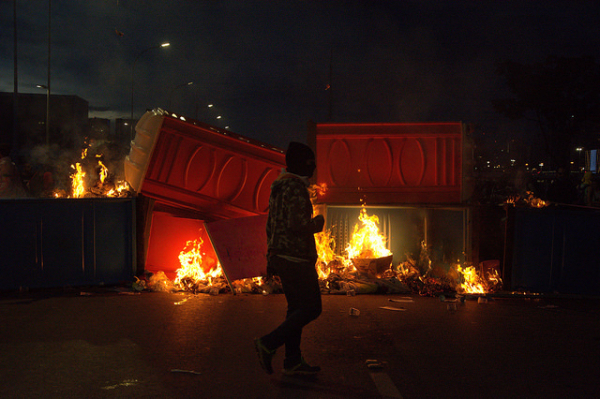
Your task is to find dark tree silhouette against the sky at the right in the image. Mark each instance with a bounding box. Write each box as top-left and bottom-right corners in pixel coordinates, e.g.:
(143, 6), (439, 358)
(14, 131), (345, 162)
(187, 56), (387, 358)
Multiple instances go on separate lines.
(492, 56), (600, 167)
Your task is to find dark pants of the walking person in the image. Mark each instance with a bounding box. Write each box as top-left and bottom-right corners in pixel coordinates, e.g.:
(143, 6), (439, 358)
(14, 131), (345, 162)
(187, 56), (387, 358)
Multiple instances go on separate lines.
(261, 256), (321, 368)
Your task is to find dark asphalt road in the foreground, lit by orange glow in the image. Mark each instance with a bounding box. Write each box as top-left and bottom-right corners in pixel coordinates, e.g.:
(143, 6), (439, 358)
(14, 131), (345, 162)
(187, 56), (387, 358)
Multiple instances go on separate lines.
(0, 288), (600, 399)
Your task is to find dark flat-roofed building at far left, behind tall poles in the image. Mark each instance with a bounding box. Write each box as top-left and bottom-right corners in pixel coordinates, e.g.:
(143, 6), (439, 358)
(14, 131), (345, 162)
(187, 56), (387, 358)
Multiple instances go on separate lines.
(0, 92), (89, 149)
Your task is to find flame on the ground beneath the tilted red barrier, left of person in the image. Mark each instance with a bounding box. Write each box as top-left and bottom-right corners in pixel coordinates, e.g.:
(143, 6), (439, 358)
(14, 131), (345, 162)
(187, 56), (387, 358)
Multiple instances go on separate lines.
(175, 238), (223, 285)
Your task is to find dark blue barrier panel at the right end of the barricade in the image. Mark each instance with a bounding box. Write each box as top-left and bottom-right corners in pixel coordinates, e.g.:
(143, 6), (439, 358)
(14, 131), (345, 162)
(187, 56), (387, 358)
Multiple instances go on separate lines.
(505, 207), (600, 295)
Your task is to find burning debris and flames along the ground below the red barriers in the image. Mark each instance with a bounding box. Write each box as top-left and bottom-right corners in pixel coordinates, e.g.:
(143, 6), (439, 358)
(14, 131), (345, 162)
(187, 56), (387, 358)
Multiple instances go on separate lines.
(150, 192), (502, 296)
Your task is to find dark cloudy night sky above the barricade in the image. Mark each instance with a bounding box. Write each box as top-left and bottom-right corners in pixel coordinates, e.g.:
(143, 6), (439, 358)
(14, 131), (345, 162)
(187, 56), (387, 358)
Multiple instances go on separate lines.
(0, 0), (600, 148)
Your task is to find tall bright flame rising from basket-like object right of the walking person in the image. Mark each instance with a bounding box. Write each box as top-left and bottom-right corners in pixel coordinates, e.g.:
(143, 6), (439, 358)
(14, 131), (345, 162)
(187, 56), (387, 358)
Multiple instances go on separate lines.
(346, 208), (392, 259)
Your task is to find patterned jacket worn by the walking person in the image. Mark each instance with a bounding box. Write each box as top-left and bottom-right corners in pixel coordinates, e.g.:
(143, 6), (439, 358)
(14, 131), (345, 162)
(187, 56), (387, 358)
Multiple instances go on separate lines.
(267, 172), (318, 262)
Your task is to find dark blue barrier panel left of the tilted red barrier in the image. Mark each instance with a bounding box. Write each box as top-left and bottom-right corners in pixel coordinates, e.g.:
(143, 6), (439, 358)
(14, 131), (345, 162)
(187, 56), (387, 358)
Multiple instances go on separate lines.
(0, 198), (136, 290)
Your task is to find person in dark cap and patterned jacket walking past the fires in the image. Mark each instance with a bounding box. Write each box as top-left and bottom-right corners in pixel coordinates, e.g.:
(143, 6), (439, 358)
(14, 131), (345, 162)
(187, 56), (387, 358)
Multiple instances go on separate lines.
(254, 142), (325, 375)
